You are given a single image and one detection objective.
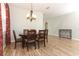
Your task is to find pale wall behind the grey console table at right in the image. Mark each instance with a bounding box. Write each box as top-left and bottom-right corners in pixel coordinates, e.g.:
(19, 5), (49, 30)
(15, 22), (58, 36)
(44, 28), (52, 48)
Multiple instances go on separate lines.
(44, 11), (79, 40)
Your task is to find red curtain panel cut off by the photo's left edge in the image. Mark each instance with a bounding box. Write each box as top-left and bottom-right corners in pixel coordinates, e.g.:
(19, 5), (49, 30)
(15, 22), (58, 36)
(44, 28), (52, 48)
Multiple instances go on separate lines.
(0, 4), (3, 56)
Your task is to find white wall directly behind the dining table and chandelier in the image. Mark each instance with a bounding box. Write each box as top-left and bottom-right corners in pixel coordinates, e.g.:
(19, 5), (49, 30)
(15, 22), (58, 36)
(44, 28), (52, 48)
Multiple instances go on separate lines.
(10, 5), (43, 42)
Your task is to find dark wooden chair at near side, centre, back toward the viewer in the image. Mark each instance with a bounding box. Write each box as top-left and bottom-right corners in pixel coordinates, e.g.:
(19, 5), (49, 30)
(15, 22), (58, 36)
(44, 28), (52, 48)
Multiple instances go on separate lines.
(26, 30), (36, 50)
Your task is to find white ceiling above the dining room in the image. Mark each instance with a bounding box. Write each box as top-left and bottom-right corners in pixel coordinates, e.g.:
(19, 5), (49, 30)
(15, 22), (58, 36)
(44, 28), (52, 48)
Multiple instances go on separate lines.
(9, 3), (79, 17)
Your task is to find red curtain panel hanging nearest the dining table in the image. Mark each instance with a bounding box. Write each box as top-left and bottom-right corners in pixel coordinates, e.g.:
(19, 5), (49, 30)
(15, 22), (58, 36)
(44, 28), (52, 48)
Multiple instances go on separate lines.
(5, 3), (11, 45)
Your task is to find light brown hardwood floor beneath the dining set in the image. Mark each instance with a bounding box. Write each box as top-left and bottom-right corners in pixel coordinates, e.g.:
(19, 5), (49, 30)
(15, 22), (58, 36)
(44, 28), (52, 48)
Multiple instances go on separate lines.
(4, 36), (79, 56)
